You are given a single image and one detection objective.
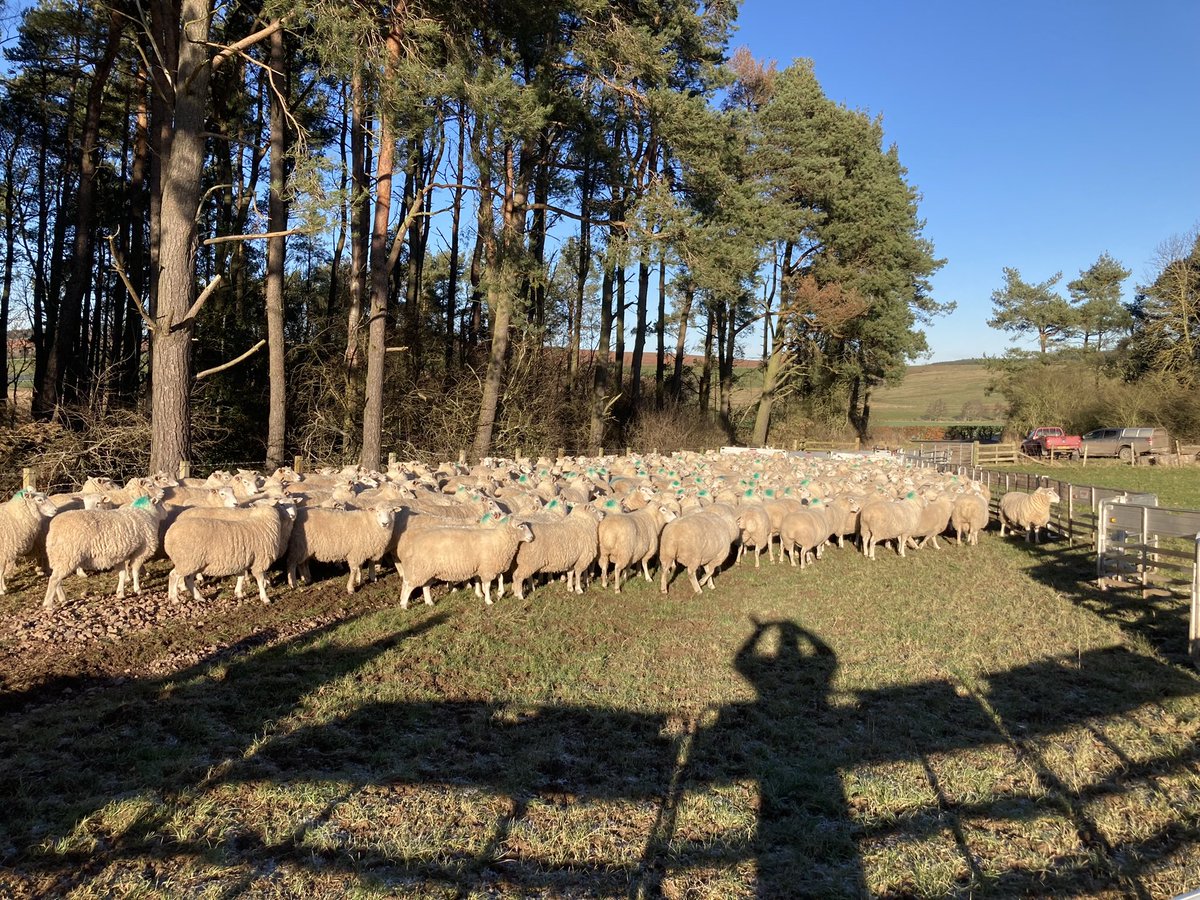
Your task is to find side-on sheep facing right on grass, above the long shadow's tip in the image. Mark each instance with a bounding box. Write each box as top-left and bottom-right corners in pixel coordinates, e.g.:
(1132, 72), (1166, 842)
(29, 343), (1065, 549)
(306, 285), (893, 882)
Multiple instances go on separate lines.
(400, 518), (534, 610)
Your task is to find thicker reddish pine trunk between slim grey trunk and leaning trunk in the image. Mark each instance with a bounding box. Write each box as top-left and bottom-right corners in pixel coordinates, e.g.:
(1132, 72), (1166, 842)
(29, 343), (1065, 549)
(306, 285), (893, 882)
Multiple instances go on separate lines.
(359, 29), (401, 470)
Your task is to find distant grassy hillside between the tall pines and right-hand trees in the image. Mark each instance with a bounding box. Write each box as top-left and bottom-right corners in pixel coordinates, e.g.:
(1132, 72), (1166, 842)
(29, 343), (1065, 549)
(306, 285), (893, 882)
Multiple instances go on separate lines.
(871, 360), (1007, 425)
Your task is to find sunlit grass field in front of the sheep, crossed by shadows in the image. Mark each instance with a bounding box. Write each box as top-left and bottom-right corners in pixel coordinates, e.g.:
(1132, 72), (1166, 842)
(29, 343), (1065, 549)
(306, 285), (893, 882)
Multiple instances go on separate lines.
(0, 466), (1200, 898)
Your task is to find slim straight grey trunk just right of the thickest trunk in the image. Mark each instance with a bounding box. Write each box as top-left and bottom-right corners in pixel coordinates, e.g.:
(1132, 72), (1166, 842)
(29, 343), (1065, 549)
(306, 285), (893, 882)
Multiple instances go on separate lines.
(265, 21), (289, 472)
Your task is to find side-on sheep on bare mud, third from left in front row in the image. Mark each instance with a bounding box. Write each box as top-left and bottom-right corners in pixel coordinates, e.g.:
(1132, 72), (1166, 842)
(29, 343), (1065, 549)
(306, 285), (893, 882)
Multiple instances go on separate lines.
(164, 502), (295, 604)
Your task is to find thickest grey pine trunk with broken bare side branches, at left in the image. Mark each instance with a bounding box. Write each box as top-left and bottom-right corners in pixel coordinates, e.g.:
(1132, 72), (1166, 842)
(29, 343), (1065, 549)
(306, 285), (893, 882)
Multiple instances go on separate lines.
(150, 0), (212, 473)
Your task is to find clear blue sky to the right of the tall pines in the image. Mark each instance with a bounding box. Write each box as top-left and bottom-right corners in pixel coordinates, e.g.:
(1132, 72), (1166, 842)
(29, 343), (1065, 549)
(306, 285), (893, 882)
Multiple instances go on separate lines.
(731, 0), (1200, 361)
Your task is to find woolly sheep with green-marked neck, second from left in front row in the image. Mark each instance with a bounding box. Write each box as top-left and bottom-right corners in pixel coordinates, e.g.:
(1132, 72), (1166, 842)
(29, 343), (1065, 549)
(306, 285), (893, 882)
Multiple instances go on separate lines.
(42, 494), (163, 610)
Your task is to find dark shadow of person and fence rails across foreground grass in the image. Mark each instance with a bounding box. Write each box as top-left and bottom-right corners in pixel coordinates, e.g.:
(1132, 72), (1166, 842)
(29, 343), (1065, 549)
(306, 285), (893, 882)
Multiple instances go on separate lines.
(0, 613), (1200, 898)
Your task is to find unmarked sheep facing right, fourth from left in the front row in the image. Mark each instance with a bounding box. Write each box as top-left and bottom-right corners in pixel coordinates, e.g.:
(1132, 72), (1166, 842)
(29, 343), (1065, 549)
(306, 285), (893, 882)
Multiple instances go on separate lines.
(287, 506), (395, 594)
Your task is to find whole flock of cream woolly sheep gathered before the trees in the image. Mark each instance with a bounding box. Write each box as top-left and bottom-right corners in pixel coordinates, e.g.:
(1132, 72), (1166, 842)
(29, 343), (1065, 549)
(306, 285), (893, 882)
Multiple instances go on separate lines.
(0, 452), (1058, 610)
